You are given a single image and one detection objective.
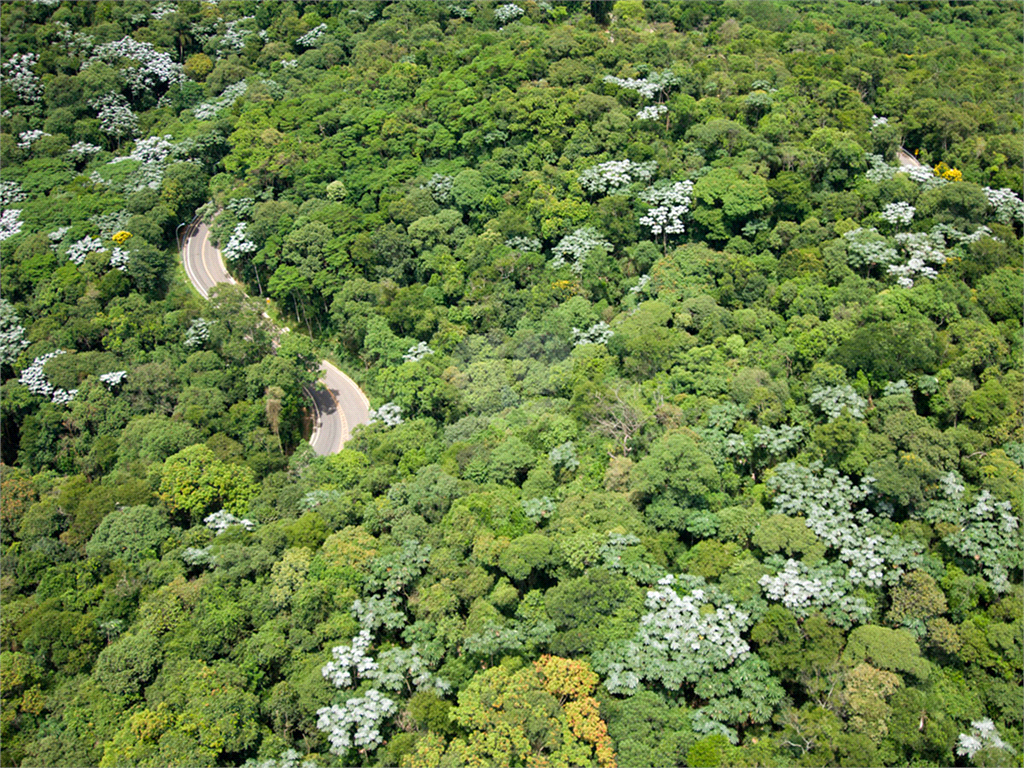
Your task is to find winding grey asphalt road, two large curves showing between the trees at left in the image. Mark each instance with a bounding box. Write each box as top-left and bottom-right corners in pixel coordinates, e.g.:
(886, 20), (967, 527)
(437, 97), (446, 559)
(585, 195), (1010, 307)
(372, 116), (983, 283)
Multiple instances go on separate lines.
(181, 221), (370, 456)
